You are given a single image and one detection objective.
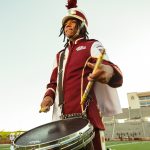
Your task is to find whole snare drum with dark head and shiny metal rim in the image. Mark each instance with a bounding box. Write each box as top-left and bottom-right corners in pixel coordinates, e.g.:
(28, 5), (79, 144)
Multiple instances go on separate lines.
(14, 118), (94, 150)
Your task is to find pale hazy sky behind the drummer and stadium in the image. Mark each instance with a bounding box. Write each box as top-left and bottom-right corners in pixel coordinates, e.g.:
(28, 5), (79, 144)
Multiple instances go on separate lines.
(0, 0), (150, 131)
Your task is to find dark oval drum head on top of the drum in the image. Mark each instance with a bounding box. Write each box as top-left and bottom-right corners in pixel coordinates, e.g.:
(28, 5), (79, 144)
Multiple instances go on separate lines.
(14, 118), (91, 147)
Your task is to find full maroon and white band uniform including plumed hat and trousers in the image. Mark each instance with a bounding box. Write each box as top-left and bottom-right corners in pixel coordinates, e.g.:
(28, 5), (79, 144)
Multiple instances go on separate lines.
(40, 0), (123, 150)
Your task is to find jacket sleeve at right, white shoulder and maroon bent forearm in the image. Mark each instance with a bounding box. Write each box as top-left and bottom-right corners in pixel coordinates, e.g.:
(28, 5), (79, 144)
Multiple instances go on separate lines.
(91, 41), (123, 88)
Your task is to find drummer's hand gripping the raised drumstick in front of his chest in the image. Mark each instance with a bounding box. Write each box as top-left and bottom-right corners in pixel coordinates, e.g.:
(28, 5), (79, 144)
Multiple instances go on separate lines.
(87, 62), (114, 84)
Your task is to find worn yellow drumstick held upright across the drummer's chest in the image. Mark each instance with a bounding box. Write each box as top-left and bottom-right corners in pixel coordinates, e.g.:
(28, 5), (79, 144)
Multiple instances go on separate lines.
(80, 48), (105, 112)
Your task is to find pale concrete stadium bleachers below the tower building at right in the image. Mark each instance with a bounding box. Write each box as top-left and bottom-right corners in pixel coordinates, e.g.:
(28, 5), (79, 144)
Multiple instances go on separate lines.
(104, 107), (150, 139)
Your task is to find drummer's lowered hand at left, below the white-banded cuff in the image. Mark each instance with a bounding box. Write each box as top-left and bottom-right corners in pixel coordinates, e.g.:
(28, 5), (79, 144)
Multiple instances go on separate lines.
(39, 96), (53, 113)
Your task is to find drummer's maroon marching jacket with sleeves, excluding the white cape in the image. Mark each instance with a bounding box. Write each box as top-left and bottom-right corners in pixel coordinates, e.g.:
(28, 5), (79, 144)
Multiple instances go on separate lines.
(45, 39), (123, 129)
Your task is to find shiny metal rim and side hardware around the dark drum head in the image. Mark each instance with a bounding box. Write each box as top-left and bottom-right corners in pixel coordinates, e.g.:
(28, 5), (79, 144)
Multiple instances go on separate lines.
(14, 118), (95, 150)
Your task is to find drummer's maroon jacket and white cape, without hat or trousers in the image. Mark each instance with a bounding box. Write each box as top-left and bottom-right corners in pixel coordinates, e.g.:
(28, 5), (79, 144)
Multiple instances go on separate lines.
(45, 39), (123, 150)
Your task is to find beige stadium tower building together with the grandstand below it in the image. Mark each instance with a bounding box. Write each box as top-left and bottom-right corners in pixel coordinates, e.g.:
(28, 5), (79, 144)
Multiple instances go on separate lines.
(104, 92), (150, 140)
